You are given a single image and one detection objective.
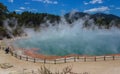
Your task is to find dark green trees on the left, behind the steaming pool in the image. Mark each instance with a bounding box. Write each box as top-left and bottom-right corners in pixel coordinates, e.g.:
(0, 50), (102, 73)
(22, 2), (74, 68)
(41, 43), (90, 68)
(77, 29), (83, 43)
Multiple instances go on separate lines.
(0, 3), (60, 39)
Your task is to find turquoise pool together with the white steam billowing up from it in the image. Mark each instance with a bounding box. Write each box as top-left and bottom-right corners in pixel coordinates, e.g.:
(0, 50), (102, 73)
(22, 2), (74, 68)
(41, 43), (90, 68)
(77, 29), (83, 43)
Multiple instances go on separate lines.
(14, 18), (120, 56)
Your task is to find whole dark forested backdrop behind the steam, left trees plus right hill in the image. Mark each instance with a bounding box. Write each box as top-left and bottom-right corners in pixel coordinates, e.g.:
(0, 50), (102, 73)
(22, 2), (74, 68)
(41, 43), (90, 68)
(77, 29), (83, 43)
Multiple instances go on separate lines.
(0, 3), (120, 39)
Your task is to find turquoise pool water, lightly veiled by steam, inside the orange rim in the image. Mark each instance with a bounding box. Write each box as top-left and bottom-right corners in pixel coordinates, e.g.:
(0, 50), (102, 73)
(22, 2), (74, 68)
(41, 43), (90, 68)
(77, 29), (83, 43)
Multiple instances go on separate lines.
(13, 30), (120, 56)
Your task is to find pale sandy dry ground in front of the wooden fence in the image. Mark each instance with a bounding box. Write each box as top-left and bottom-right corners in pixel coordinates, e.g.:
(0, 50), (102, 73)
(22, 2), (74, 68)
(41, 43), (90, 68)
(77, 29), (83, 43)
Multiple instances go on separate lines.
(0, 50), (120, 74)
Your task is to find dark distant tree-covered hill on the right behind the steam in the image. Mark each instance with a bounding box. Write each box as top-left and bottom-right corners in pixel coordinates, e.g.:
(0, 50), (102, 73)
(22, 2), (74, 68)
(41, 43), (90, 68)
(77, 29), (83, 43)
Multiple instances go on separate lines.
(64, 12), (120, 29)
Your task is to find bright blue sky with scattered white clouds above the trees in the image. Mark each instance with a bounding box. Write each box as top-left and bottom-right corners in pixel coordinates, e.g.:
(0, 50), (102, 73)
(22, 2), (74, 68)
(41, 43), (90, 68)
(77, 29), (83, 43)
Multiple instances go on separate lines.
(0, 0), (120, 16)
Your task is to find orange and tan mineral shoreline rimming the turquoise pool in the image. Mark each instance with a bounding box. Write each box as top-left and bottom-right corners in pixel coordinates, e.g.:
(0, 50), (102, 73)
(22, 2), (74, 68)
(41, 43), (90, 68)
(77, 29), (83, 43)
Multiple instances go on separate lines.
(0, 37), (120, 62)
